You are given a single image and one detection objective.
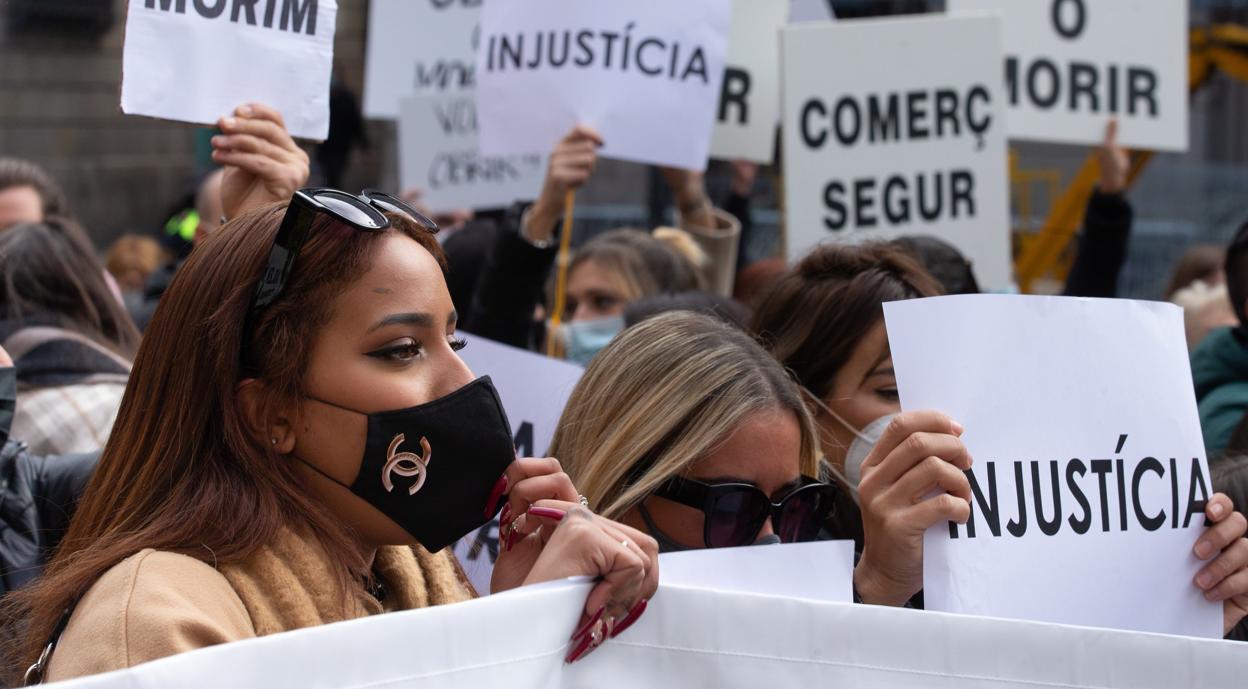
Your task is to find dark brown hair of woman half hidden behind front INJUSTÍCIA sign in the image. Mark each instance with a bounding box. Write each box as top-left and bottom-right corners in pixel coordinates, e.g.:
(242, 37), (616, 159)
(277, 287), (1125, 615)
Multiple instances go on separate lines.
(753, 242), (943, 398)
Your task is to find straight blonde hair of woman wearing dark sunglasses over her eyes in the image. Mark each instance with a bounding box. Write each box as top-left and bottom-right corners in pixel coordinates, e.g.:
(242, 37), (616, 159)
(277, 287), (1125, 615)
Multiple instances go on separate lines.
(550, 312), (820, 519)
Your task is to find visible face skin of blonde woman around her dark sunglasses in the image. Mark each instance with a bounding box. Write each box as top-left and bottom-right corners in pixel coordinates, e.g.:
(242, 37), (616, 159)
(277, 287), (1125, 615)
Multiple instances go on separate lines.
(624, 409), (801, 548)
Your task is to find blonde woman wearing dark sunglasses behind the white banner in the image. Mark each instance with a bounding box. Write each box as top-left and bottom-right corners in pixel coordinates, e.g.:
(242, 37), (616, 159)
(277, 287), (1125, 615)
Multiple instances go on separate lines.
(550, 312), (940, 604)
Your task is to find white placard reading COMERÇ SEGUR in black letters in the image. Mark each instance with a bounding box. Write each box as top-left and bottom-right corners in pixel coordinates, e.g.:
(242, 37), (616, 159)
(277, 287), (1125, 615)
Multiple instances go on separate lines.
(782, 15), (1011, 290)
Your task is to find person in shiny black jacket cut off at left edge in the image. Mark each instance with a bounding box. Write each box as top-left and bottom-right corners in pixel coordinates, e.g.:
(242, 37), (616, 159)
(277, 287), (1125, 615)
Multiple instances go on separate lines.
(0, 348), (100, 595)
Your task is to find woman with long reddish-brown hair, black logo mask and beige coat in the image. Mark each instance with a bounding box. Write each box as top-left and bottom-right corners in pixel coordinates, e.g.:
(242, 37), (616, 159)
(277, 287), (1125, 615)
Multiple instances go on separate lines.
(6, 190), (658, 680)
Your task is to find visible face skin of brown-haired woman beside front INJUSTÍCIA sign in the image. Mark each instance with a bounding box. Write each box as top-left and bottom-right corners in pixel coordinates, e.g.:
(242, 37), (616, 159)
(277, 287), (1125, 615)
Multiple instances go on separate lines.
(815, 320), (901, 467)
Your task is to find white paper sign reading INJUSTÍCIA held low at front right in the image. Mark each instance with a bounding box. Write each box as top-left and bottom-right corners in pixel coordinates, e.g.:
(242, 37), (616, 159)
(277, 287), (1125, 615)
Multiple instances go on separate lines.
(884, 295), (1222, 638)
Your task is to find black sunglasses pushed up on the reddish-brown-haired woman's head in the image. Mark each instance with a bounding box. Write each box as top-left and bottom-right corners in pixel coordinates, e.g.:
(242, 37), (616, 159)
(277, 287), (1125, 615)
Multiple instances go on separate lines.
(242, 187), (438, 356)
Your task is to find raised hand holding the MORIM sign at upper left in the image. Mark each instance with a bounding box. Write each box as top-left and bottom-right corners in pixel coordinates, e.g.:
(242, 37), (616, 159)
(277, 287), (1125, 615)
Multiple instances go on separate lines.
(212, 104), (310, 218)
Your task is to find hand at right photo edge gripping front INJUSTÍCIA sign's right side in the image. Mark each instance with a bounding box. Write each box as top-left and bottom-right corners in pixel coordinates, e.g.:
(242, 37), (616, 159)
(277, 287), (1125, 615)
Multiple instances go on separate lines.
(1192, 493), (1248, 634)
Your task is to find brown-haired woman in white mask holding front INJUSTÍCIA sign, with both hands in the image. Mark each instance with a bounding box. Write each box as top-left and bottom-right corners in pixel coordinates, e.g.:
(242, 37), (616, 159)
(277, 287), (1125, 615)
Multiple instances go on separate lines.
(754, 243), (1248, 632)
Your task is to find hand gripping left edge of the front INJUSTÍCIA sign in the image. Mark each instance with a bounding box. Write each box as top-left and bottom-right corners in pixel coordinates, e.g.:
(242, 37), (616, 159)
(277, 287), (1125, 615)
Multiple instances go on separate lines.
(854, 412), (971, 605)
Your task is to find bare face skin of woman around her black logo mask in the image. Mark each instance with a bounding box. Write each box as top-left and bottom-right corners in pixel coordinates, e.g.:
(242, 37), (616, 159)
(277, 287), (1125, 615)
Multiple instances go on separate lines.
(283, 233), (473, 545)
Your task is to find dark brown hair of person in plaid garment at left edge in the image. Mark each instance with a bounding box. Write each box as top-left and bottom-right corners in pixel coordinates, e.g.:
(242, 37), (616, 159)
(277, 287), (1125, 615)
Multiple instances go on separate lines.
(0, 216), (139, 359)
